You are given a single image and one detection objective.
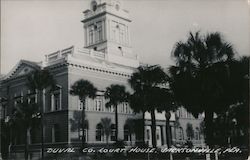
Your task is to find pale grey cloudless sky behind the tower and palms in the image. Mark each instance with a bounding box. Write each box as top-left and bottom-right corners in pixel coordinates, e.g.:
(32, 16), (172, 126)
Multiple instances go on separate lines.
(0, 0), (250, 74)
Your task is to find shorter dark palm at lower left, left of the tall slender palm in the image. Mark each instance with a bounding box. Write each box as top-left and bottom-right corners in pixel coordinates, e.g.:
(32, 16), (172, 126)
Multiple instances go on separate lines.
(13, 99), (41, 160)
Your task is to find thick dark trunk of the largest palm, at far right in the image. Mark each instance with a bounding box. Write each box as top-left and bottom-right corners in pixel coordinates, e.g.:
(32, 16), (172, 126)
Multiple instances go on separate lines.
(205, 111), (213, 147)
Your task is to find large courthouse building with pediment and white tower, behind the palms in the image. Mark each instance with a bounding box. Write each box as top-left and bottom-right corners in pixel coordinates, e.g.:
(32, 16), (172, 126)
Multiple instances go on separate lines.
(0, 0), (203, 156)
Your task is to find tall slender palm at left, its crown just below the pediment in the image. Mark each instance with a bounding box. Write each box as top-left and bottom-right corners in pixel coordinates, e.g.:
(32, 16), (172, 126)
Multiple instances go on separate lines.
(27, 69), (55, 159)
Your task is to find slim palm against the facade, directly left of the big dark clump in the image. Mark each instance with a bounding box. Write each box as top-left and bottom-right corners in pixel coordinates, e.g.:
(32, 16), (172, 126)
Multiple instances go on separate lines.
(104, 84), (129, 141)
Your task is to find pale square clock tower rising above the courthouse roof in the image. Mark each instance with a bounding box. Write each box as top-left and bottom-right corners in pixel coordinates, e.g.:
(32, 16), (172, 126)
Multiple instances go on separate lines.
(82, 0), (137, 66)
